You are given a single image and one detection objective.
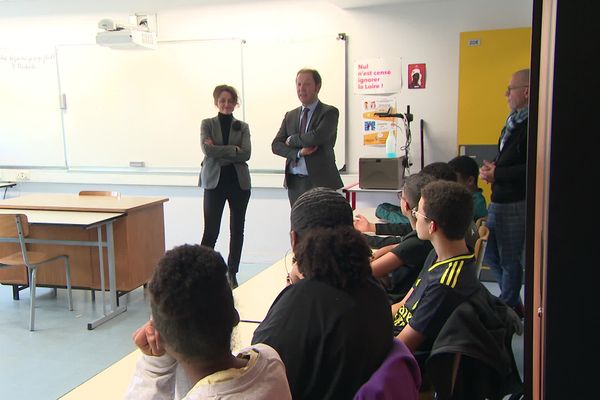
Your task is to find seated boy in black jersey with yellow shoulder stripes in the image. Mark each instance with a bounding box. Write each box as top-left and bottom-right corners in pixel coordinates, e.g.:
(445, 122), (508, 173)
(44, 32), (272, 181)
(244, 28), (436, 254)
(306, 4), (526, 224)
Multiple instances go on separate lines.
(392, 180), (480, 358)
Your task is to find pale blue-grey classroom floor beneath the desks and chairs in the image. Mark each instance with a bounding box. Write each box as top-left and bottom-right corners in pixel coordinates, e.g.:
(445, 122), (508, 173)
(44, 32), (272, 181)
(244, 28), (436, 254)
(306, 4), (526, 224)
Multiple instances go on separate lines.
(0, 264), (523, 400)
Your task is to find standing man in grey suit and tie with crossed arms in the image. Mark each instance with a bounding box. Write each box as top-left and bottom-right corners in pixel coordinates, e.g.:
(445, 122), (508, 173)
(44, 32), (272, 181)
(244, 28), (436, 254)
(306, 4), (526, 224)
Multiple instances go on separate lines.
(271, 69), (343, 205)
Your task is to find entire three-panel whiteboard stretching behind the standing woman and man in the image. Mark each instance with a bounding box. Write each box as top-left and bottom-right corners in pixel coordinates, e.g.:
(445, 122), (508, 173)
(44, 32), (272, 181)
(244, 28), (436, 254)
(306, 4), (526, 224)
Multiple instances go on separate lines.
(0, 36), (346, 173)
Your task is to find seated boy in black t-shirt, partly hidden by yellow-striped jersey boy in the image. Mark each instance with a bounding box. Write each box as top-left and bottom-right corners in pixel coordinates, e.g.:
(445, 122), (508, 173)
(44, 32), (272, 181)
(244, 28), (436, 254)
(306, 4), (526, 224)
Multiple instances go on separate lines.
(371, 173), (436, 303)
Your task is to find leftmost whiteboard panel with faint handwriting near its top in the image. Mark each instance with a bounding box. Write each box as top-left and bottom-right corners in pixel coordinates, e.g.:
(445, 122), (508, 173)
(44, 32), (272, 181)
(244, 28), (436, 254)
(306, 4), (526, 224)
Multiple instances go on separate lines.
(0, 48), (65, 167)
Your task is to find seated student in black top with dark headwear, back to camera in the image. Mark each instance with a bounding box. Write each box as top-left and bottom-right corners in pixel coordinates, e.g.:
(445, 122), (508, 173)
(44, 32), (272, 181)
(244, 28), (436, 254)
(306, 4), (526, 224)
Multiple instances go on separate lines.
(252, 188), (393, 400)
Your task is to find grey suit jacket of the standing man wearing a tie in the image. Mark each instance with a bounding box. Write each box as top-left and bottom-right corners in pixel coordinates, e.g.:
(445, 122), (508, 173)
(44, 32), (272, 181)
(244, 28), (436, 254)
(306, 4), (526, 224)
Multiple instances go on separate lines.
(271, 101), (343, 189)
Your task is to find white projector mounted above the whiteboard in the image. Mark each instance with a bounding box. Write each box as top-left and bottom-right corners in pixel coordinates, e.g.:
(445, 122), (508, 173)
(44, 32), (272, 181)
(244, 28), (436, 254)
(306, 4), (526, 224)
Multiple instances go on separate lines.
(96, 16), (157, 50)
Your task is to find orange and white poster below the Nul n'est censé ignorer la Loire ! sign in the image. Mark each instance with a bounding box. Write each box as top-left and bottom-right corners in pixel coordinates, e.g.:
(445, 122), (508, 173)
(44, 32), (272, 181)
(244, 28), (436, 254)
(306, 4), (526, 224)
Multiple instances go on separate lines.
(361, 96), (396, 145)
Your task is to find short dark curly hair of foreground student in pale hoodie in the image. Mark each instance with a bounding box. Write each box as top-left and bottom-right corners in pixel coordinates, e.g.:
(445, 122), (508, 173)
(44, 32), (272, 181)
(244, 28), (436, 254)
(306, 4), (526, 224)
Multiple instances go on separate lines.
(148, 244), (239, 360)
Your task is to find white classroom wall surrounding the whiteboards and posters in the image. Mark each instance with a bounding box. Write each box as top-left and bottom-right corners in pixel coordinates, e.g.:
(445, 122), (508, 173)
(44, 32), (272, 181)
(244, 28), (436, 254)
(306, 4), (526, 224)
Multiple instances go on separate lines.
(0, 0), (532, 263)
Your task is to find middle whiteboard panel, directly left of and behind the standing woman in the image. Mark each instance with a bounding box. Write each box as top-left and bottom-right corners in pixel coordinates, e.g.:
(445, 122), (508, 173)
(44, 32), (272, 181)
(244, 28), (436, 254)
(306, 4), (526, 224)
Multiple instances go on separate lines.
(57, 40), (242, 170)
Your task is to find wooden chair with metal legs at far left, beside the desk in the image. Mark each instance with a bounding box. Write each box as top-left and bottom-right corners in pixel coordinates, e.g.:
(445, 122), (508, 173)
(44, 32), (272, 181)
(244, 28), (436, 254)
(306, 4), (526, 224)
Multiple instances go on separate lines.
(0, 214), (73, 331)
